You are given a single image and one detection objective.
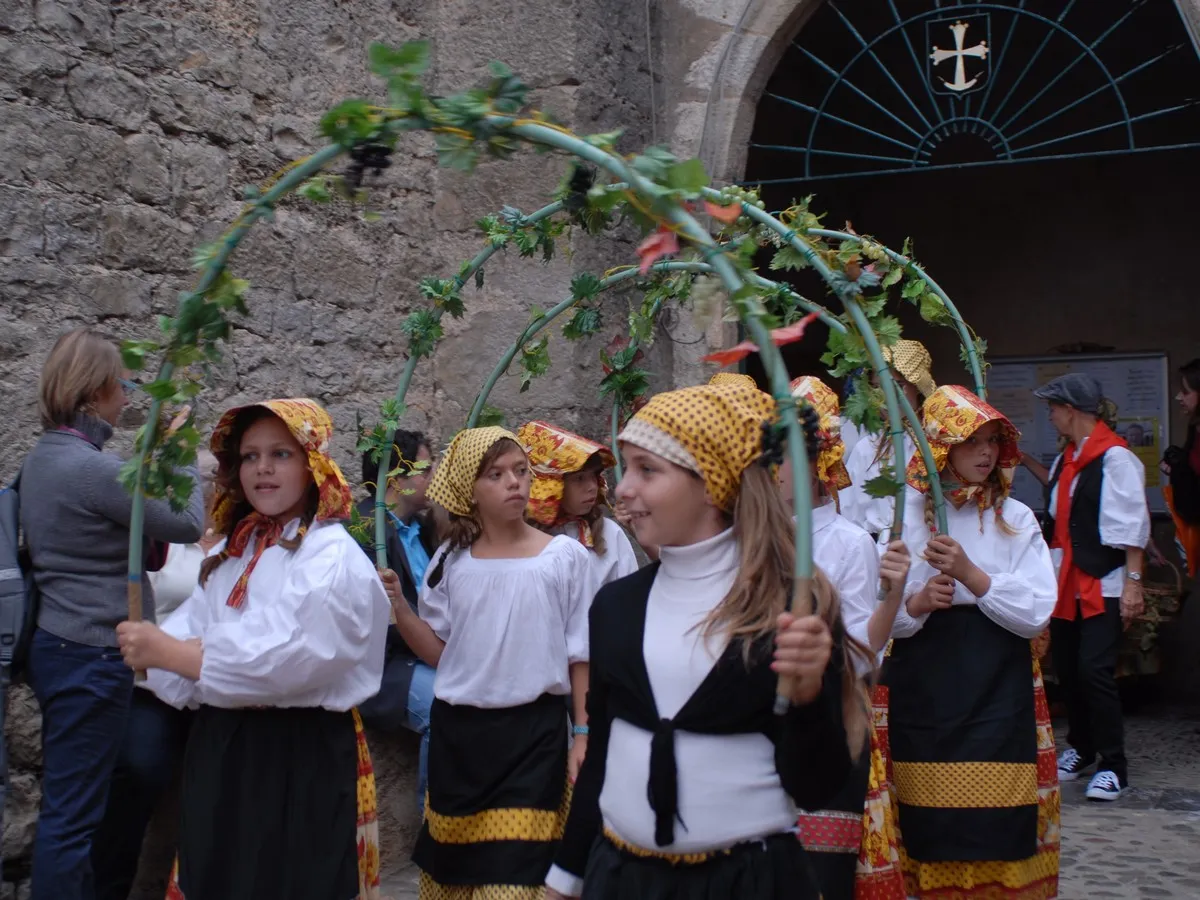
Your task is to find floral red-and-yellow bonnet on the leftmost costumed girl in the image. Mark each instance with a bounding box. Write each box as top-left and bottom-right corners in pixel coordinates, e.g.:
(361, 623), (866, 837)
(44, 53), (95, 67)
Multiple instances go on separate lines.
(209, 397), (353, 534)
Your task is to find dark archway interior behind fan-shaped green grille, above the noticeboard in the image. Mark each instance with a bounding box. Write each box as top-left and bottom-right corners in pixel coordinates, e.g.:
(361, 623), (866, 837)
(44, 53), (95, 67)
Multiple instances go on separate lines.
(745, 0), (1200, 436)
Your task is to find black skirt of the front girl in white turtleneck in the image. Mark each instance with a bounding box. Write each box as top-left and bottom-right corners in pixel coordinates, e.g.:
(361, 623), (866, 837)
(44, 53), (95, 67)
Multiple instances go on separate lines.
(582, 833), (821, 900)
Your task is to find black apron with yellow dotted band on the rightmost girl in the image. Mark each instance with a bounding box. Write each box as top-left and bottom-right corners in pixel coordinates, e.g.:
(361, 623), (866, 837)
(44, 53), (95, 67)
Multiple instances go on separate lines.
(883, 606), (1038, 862)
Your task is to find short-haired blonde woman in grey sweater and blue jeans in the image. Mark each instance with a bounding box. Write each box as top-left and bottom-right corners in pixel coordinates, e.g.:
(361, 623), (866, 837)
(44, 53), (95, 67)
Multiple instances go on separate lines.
(20, 329), (204, 900)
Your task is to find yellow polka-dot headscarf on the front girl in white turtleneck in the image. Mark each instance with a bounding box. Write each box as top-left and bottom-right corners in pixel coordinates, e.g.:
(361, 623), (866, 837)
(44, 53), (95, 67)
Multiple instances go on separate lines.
(619, 379), (778, 511)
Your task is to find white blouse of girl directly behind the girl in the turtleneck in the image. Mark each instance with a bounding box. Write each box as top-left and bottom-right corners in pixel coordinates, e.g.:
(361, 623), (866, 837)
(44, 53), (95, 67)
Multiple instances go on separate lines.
(812, 503), (882, 677)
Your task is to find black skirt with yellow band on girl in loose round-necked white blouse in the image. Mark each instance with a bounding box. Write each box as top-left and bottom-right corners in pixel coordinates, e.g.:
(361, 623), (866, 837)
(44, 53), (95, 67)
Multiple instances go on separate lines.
(412, 694), (570, 900)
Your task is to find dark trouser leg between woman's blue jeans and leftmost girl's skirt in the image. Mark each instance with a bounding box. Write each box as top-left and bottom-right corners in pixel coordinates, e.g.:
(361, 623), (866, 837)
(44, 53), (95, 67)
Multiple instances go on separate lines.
(91, 689), (192, 900)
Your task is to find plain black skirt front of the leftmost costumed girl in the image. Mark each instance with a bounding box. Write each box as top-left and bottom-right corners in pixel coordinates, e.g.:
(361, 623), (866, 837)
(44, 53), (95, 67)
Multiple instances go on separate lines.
(179, 707), (359, 900)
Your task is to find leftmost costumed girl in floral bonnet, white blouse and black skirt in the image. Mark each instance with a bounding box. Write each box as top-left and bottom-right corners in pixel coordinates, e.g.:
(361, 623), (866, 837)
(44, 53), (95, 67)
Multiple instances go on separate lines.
(118, 400), (389, 900)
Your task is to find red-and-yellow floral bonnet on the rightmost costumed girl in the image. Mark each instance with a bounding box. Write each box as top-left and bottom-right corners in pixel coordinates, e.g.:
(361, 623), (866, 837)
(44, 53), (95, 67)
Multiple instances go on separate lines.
(906, 384), (1021, 506)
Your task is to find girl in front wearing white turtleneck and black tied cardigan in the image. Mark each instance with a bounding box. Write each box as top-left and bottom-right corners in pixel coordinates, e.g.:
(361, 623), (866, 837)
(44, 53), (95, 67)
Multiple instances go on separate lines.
(546, 383), (866, 900)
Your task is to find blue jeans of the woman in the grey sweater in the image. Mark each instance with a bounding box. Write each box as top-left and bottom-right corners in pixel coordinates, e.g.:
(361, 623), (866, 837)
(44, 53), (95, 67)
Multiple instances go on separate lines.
(29, 629), (133, 900)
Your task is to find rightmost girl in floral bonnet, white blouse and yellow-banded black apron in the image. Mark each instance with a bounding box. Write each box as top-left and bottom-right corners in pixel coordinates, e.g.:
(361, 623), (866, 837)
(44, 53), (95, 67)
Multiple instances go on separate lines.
(877, 386), (1058, 900)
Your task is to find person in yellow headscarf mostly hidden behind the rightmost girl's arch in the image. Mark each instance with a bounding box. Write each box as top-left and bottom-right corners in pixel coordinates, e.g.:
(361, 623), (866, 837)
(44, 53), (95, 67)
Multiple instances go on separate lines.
(841, 340), (937, 534)
